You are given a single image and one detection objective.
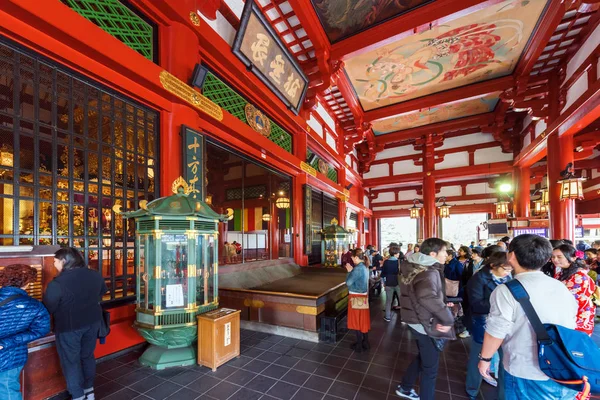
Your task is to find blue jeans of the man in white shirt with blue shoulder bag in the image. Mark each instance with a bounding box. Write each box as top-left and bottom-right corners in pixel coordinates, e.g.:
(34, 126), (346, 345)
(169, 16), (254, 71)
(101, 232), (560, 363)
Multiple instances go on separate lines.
(504, 372), (577, 400)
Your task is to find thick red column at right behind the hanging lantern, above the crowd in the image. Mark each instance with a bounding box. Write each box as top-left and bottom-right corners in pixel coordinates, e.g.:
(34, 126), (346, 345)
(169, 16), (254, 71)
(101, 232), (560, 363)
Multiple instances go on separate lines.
(548, 134), (575, 241)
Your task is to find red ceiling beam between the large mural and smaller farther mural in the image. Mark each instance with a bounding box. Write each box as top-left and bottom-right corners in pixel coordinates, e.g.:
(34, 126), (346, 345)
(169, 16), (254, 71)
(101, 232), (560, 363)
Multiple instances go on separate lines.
(364, 76), (515, 122)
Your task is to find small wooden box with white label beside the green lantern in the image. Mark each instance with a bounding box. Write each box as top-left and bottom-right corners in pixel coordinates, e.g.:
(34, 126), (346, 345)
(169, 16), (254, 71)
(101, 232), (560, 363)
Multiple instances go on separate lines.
(198, 308), (240, 371)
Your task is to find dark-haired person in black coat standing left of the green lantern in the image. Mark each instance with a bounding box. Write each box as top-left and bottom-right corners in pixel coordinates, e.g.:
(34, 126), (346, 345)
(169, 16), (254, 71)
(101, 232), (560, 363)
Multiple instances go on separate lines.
(44, 247), (108, 400)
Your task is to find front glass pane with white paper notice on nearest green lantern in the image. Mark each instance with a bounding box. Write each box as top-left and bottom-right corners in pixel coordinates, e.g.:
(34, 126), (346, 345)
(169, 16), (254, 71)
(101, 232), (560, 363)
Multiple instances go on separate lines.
(160, 234), (188, 309)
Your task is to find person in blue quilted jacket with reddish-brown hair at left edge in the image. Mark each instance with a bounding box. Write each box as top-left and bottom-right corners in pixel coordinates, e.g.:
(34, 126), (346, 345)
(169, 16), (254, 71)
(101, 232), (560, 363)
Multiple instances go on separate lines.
(0, 264), (50, 400)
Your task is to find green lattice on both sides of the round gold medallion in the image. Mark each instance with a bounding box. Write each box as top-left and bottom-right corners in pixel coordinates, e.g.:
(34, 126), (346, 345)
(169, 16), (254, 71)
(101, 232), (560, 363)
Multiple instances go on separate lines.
(202, 73), (292, 153)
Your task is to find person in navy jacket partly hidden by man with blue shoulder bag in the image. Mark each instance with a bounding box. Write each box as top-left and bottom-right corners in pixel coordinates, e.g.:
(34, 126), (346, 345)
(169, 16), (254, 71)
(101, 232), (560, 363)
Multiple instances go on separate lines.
(466, 251), (512, 400)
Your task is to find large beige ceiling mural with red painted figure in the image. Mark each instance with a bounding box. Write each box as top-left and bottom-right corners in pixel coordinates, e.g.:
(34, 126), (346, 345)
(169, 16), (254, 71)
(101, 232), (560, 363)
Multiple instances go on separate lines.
(345, 0), (547, 111)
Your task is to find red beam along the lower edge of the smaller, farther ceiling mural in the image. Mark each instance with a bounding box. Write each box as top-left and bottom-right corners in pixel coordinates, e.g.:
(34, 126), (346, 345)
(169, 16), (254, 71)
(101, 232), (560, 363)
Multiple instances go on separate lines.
(375, 113), (494, 145)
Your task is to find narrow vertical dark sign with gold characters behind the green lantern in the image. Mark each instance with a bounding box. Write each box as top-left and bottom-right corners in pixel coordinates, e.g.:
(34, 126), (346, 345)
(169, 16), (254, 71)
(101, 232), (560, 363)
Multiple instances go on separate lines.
(181, 126), (204, 201)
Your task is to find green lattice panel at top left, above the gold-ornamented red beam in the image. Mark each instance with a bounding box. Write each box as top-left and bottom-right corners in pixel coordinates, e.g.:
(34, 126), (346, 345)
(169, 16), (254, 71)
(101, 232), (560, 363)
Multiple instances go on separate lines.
(61, 0), (155, 61)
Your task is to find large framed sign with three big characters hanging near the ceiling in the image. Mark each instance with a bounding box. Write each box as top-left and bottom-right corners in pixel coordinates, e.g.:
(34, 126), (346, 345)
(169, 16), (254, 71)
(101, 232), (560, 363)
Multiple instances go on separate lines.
(233, 0), (308, 114)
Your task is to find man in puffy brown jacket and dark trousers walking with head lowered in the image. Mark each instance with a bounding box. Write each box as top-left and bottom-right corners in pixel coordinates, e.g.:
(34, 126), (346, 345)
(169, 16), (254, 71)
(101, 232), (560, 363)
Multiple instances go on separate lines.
(396, 238), (456, 400)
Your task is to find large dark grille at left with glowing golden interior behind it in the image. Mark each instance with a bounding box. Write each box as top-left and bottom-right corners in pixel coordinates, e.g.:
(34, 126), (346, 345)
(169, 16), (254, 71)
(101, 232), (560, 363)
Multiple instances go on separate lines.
(0, 39), (158, 301)
